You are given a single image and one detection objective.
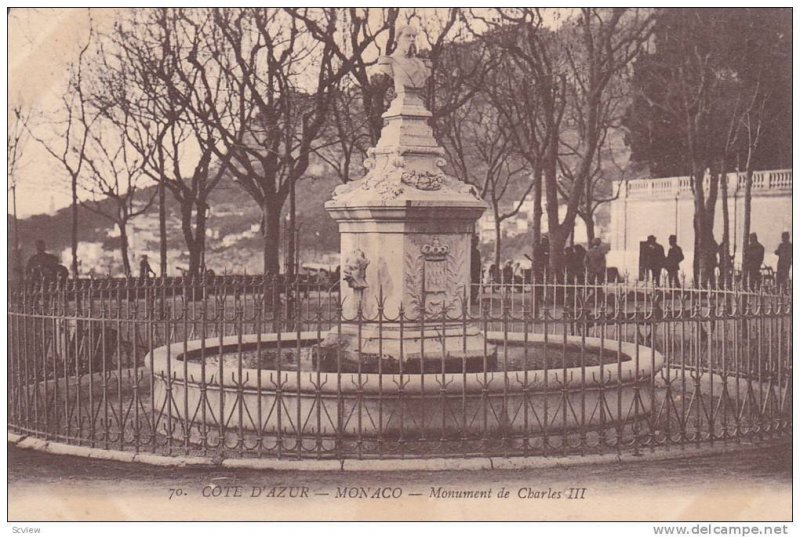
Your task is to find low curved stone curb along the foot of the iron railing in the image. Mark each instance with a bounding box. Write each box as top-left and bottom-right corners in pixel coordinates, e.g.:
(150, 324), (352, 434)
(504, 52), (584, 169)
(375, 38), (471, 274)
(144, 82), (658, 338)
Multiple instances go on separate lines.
(8, 433), (791, 472)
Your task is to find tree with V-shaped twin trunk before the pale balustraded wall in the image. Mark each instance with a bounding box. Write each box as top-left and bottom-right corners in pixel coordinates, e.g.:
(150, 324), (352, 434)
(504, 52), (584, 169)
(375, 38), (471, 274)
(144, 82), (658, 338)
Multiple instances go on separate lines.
(642, 9), (748, 284)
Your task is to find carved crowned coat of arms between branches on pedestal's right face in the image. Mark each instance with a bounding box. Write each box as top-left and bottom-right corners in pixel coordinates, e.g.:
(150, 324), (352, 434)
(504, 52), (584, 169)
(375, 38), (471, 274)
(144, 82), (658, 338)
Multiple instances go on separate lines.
(404, 235), (468, 318)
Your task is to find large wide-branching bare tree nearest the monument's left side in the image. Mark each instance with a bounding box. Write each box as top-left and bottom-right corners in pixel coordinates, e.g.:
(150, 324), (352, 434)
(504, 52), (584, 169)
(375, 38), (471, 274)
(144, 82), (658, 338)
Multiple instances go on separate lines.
(180, 9), (387, 275)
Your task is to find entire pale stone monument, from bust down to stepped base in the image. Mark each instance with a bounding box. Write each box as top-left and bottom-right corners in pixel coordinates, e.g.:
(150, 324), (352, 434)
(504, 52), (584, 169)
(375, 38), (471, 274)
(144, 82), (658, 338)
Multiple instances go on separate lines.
(320, 26), (495, 373)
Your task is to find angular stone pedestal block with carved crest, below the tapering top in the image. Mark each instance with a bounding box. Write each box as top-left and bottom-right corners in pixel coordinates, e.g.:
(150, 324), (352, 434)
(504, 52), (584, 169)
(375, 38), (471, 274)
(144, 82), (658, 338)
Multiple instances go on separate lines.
(320, 201), (496, 373)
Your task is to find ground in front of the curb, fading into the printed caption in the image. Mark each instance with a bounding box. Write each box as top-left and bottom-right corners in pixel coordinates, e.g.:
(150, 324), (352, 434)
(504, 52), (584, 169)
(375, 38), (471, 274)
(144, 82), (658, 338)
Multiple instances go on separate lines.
(8, 446), (792, 521)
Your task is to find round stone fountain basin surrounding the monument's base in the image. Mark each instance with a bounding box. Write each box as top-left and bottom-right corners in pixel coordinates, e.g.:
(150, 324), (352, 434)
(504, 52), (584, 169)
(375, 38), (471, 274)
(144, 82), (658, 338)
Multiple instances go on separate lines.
(146, 332), (664, 439)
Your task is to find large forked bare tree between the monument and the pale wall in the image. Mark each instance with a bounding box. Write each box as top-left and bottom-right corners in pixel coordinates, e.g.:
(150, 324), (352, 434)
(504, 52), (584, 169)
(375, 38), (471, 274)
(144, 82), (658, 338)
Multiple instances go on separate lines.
(478, 8), (652, 271)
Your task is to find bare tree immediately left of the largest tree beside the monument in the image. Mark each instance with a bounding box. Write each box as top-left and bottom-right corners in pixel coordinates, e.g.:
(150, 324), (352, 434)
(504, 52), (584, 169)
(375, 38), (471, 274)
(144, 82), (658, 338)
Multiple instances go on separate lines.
(97, 8), (230, 275)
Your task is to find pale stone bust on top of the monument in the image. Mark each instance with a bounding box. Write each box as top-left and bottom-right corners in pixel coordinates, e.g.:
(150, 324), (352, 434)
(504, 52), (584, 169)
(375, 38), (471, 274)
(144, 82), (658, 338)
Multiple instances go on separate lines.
(377, 26), (431, 115)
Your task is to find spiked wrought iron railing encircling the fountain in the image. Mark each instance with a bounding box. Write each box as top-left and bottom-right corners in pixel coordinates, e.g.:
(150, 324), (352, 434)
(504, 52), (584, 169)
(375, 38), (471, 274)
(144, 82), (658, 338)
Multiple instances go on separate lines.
(8, 278), (792, 459)
